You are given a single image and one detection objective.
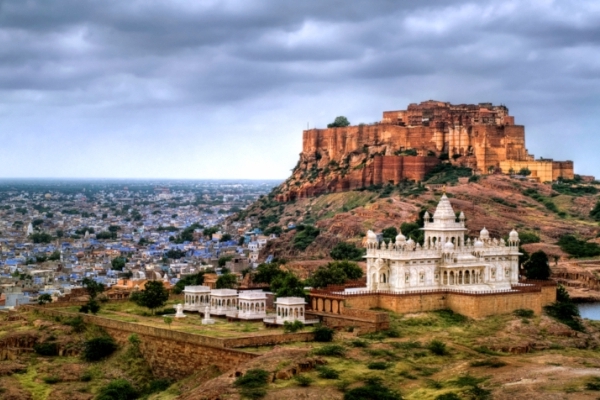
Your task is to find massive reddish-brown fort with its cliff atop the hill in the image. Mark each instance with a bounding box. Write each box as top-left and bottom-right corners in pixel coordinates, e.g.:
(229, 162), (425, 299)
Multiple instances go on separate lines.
(278, 100), (574, 201)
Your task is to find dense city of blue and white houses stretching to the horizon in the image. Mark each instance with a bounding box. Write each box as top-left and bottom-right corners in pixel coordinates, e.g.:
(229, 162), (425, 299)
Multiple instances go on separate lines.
(0, 180), (277, 307)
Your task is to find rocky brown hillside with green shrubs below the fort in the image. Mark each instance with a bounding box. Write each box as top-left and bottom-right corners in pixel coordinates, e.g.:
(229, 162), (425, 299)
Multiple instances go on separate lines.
(238, 173), (600, 260)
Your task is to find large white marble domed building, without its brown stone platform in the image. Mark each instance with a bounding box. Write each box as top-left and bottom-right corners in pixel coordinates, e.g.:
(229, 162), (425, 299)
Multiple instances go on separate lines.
(360, 194), (520, 292)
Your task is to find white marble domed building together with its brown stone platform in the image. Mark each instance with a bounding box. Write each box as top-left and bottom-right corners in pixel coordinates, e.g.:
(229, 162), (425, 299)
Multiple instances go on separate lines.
(311, 194), (556, 320)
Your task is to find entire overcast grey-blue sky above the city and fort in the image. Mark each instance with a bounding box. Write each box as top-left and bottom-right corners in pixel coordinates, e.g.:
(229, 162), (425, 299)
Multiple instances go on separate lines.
(0, 0), (600, 179)
